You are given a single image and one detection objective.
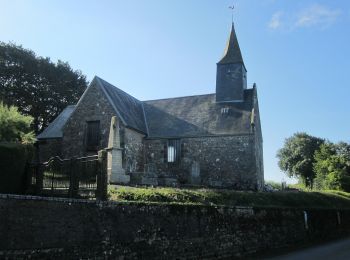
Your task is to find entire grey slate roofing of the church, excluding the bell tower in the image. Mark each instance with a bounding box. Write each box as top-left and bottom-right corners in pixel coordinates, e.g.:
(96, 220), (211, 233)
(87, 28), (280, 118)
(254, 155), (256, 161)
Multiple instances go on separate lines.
(37, 77), (254, 139)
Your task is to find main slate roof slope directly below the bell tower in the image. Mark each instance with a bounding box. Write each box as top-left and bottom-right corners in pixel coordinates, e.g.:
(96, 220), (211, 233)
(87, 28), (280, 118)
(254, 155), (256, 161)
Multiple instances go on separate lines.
(143, 89), (253, 138)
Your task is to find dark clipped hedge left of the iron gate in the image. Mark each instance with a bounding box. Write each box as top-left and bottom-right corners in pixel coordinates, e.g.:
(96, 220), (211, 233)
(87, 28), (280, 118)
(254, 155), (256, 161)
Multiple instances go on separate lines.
(0, 143), (34, 194)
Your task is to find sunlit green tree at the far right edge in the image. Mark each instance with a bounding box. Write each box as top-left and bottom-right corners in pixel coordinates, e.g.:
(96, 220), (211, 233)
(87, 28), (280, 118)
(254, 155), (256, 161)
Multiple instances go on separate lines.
(314, 142), (350, 191)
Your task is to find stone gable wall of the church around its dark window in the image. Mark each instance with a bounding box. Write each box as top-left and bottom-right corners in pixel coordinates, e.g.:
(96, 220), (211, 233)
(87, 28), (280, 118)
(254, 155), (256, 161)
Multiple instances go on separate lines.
(62, 81), (115, 158)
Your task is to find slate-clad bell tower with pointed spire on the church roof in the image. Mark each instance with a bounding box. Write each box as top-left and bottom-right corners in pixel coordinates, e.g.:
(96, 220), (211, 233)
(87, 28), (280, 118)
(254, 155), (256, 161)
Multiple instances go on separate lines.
(216, 23), (247, 103)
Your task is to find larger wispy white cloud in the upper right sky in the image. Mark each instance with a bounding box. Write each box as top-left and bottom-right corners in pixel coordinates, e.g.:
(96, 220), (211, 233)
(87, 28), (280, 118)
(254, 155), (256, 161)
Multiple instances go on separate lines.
(294, 4), (341, 28)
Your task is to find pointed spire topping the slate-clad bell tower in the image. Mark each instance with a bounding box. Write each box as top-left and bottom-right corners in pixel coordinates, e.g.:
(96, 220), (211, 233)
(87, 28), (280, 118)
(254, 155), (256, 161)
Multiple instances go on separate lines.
(218, 23), (244, 64)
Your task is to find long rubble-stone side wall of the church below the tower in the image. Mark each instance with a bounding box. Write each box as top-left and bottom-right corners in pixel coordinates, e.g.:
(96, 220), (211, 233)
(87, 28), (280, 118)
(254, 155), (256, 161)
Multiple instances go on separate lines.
(145, 135), (258, 190)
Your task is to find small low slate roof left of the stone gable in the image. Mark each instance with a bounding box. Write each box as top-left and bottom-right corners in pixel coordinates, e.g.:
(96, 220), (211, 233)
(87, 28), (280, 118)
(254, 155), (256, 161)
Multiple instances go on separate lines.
(37, 105), (75, 139)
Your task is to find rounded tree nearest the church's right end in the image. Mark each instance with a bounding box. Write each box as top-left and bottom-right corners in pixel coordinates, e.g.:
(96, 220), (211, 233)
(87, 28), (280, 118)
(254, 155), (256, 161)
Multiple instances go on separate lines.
(277, 133), (324, 189)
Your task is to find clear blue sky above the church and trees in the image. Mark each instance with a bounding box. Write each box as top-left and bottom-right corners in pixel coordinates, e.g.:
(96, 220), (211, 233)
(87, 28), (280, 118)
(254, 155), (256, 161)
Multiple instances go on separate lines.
(0, 0), (350, 182)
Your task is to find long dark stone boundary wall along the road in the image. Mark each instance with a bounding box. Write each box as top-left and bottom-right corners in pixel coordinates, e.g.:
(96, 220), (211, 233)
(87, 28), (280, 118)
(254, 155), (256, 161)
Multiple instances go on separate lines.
(0, 195), (350, 259)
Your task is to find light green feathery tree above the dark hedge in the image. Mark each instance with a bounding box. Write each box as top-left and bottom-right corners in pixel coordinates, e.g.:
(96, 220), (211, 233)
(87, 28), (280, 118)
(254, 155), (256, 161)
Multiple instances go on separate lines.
(0, 102), (35, 143)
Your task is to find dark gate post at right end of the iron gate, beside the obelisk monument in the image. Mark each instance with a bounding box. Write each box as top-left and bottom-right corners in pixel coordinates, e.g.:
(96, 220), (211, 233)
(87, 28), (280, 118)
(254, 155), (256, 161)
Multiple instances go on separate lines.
(96, 150), (108, 200)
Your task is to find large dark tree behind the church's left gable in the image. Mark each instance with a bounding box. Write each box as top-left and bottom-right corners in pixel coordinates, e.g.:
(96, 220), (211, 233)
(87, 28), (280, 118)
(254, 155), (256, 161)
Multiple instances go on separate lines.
(0, 42), (88, 134)
